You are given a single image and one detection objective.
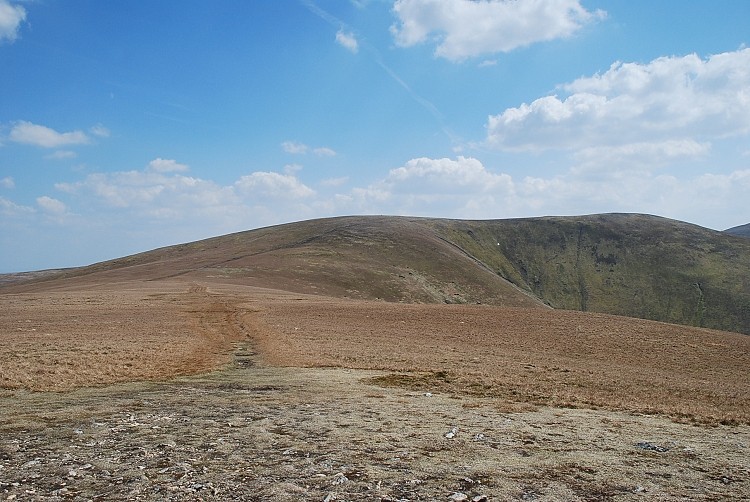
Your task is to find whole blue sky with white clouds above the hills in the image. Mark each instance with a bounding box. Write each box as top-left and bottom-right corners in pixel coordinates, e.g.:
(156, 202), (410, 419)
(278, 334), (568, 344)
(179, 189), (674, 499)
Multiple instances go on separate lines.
(0, 0), (750, 273)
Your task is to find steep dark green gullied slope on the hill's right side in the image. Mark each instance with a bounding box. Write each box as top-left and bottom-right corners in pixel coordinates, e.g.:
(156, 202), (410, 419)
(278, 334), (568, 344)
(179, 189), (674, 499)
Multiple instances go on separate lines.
(433, 214), (750, 333)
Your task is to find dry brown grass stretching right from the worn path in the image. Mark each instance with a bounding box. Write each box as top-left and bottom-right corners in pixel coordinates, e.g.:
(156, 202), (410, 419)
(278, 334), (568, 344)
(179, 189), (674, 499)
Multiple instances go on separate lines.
(251, 300), (750, 423)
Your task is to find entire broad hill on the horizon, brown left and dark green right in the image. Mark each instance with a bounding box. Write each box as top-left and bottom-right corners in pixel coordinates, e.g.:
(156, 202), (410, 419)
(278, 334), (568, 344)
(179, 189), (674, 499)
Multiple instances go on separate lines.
(6, 214), (750, 334)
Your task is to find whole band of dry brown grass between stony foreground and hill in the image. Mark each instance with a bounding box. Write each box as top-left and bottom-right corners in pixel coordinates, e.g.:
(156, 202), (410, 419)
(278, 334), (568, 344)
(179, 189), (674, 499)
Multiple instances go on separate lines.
(0, 276), (750, 424)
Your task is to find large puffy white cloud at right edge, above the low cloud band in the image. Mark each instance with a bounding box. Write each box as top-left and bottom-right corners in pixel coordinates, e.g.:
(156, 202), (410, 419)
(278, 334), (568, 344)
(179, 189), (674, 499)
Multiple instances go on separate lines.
(487, 49), (750, 151)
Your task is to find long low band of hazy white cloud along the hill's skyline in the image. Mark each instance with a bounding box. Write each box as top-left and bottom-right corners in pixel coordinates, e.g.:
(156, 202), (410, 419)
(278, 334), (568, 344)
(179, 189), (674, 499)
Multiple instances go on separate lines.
(7, 154), (750, 266)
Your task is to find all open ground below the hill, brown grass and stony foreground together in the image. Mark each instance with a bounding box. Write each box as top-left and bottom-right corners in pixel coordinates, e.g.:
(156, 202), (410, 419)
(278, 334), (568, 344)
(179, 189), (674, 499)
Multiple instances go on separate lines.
(0, 281), (750, 501)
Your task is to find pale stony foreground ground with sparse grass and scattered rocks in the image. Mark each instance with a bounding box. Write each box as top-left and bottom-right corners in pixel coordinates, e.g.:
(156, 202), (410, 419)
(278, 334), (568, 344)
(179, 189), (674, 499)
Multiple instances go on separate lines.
(0, 346), (750, 501)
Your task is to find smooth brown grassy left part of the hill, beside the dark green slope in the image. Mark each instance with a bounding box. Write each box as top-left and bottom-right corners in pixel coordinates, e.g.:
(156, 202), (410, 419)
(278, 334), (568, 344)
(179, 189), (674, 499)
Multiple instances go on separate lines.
(2, 217), (546, 308)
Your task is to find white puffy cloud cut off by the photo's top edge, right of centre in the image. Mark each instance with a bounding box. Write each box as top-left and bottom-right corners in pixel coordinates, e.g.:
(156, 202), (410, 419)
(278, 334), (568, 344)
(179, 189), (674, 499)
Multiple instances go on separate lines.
(391, 0), (604, 61)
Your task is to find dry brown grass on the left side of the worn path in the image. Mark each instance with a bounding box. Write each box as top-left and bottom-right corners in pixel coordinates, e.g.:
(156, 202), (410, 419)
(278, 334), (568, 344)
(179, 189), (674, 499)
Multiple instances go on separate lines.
(0, 287), (247, 391)
